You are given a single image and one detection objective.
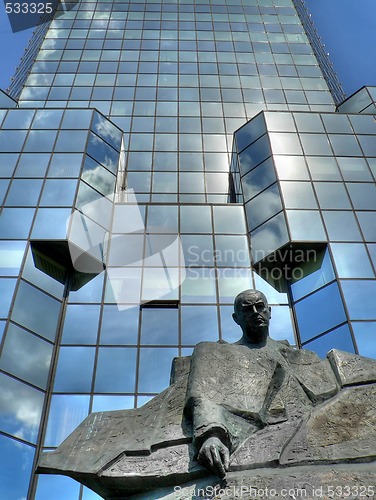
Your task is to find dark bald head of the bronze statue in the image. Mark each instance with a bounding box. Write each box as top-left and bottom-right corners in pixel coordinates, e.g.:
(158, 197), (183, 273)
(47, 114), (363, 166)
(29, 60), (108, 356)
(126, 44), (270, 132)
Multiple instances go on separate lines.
(232, 290), (271, 344)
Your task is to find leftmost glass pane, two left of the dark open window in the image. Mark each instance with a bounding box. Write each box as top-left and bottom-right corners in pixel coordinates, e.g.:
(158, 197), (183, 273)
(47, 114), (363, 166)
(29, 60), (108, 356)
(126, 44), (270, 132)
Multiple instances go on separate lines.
(62, 304), (100, 344)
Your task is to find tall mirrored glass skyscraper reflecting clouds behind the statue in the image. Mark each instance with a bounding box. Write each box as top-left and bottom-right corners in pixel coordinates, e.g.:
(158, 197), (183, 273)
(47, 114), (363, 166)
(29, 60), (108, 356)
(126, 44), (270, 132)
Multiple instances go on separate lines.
(0, 0), (376, 500)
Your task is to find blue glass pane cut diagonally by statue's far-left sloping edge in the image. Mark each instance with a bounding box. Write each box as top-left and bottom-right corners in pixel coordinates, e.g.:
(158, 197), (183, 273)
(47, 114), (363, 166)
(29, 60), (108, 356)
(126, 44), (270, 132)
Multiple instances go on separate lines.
(44, 394), (90, 447)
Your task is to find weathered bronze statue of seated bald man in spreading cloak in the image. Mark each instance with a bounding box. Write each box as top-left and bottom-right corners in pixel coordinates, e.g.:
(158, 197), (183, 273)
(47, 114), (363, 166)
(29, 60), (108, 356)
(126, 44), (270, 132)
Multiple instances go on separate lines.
(37, 290), (376, 500)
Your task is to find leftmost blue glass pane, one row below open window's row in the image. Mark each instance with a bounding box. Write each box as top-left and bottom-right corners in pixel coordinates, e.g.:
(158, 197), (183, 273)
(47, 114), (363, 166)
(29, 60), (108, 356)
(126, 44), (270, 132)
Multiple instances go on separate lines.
(54, 347), (95, 392)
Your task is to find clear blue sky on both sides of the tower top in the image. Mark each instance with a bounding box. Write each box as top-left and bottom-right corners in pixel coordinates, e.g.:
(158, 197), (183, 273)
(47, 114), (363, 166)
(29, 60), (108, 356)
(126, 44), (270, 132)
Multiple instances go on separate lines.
(0, 0), (376, 95)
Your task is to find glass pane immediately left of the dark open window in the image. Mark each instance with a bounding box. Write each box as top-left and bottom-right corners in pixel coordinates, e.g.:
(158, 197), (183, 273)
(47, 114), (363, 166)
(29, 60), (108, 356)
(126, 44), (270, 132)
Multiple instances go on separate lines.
(100, 305), (139, 345)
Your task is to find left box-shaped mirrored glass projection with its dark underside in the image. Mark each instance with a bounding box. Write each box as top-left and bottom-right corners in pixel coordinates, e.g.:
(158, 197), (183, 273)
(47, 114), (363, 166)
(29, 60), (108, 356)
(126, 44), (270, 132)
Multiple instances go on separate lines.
(0, 108), (122, 290)
